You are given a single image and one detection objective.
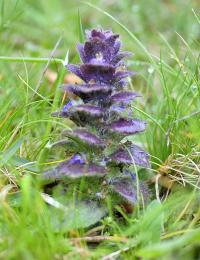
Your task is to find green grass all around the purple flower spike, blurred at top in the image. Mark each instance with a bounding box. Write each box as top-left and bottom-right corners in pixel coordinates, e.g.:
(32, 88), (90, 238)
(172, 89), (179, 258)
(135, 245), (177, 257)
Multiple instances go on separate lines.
(0, 0), (200, 259)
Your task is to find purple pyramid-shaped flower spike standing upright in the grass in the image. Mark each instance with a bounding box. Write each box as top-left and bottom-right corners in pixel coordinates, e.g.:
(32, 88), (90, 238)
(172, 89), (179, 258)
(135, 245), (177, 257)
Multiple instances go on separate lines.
(45, 29), (150, 203)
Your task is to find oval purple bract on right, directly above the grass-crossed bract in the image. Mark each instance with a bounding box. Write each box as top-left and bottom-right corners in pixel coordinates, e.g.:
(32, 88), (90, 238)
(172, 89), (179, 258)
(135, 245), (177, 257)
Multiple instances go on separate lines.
(108, 118), (146, 135)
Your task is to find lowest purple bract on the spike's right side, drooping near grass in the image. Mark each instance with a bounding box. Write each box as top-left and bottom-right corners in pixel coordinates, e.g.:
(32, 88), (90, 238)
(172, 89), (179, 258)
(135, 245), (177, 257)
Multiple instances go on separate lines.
(112, 178), (137, 204)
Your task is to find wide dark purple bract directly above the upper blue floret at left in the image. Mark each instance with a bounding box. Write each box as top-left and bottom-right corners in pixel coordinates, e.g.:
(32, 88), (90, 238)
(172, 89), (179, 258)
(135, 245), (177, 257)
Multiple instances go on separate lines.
(64, 84), (112, 101)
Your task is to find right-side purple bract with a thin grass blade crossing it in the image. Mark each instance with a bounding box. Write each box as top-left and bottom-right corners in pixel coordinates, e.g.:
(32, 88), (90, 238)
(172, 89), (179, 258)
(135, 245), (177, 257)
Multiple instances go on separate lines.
(110, 144), (150, 168)
